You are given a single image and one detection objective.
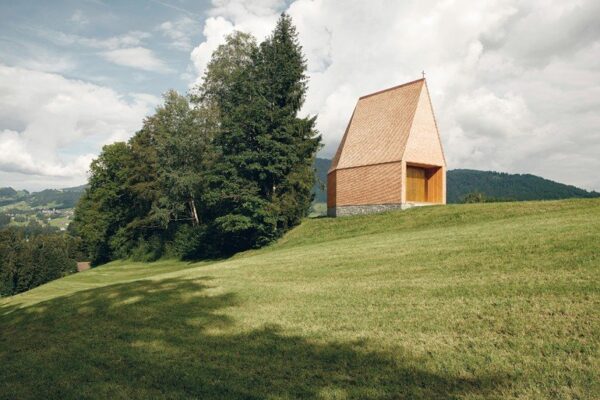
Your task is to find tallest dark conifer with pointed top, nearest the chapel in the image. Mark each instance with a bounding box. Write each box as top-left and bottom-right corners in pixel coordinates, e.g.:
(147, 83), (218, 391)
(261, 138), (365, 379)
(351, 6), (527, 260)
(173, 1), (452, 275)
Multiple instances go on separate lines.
(256, 14), (320, 230)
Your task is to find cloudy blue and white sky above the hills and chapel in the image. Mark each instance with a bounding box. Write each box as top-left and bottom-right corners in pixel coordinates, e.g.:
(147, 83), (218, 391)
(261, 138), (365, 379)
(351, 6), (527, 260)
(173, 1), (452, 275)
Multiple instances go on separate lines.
(0, 0), (600, 191)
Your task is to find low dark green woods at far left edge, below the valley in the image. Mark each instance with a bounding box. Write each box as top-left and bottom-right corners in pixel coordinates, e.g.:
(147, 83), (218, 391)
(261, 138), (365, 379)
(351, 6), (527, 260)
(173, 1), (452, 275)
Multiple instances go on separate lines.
(0, 227), (80, 296)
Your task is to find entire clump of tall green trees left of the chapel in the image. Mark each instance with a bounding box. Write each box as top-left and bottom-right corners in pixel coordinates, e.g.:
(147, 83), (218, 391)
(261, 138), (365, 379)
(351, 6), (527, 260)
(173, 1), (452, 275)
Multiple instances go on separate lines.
(70, 15), (320, 264)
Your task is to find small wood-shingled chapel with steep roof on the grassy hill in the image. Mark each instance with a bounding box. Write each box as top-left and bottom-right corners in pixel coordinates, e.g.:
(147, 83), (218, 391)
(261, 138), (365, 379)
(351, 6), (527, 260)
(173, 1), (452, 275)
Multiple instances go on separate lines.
(327, 78), (446, 217)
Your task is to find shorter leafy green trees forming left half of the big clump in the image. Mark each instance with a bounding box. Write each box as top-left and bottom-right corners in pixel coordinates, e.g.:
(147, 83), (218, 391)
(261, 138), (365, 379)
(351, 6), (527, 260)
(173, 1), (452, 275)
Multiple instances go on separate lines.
(71, 91), (215, 264)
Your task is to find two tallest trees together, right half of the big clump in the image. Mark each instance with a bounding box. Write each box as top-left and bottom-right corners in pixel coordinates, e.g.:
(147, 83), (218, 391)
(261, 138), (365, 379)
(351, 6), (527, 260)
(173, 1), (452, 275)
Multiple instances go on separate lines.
(196, 14), (320, 254)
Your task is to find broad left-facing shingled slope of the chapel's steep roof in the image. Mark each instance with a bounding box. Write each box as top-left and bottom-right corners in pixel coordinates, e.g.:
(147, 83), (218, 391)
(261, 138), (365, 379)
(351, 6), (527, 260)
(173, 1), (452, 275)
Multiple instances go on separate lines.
(330, 79), (427, 171)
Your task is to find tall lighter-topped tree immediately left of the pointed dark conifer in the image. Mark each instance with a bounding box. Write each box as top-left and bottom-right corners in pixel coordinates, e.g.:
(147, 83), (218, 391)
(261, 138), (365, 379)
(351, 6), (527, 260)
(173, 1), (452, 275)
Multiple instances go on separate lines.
(194, 32), (275, 253)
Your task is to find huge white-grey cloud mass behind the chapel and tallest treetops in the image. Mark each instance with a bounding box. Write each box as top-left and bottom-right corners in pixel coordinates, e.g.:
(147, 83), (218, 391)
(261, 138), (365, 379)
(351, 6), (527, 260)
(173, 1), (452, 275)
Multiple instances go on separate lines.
(186, 0), (600, 190)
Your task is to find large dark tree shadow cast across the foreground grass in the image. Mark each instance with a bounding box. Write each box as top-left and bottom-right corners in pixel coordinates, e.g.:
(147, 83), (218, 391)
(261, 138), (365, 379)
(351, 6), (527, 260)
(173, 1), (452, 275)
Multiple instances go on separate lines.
(0, 279), (503, 399)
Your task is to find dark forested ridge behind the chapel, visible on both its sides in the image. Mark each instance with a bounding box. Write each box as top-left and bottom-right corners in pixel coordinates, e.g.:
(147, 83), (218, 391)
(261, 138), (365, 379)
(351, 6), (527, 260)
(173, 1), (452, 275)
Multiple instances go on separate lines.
(314, 158), (600, 203)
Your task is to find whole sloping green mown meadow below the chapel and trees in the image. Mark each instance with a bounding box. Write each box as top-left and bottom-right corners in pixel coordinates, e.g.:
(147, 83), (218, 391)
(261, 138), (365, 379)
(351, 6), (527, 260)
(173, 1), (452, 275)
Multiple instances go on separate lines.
(0, 200), (600, 399)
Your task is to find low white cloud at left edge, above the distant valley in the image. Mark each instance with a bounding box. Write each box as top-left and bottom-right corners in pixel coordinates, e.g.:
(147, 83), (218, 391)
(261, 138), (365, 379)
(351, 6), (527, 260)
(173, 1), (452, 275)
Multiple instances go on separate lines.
(0, 64), (160, 189)
